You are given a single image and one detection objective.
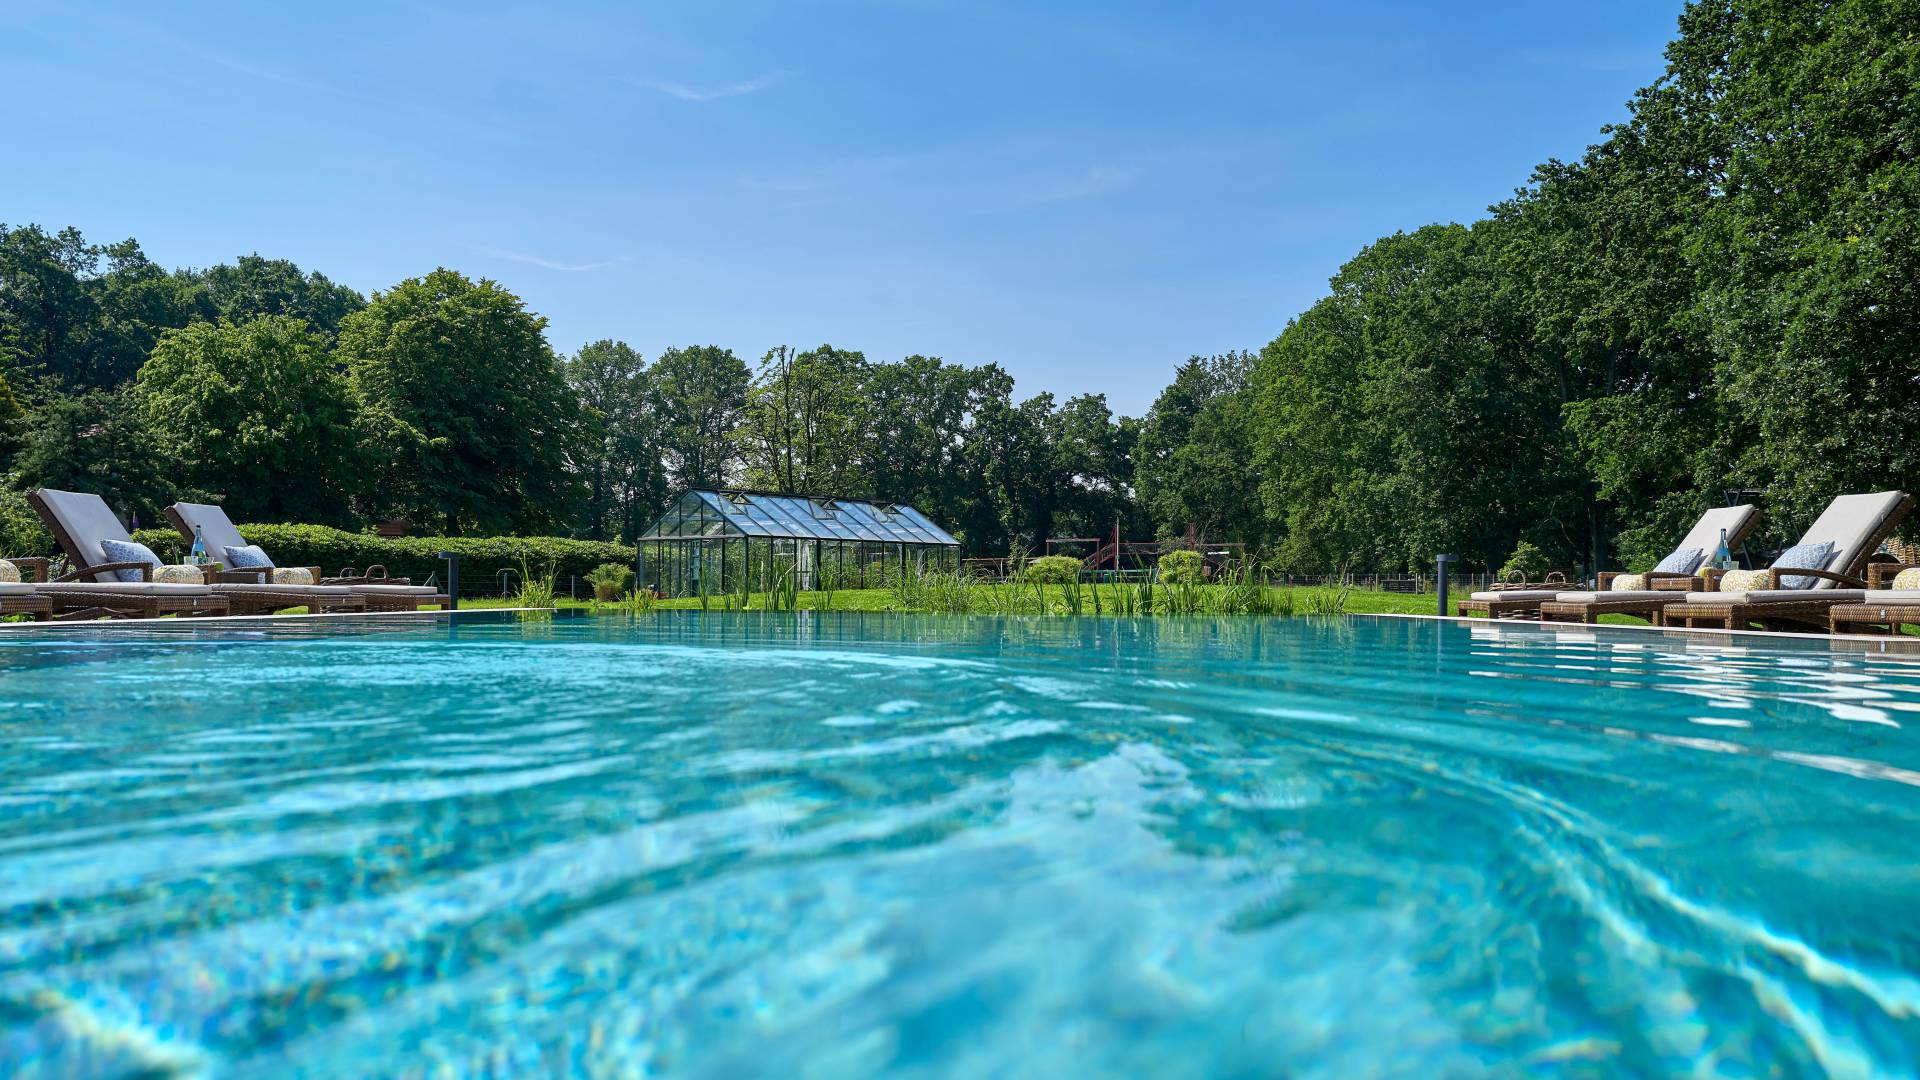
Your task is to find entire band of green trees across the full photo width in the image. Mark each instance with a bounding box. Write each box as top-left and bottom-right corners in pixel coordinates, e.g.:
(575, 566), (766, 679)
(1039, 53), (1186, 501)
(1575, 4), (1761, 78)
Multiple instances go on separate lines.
(0, 0), (1920, 571)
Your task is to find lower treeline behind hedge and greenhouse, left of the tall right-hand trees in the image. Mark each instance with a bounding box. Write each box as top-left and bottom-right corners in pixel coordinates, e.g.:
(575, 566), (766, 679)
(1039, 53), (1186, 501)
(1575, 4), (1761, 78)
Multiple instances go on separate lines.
(0, 234), (1146, 552)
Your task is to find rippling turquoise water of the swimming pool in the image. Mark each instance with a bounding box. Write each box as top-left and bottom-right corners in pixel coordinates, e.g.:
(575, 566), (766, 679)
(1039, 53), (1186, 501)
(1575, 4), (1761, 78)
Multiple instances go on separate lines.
(0, 613), (1920, 1078)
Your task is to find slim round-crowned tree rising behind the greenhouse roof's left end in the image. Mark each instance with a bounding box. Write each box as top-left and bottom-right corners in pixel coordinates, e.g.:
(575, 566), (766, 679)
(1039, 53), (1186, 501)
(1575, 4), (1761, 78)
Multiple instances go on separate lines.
(653, 346), (753, 488)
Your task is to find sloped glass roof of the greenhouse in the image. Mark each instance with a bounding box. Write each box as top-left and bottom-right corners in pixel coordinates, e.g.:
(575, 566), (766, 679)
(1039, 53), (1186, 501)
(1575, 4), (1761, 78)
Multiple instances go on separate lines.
(639, 488), (960, 548)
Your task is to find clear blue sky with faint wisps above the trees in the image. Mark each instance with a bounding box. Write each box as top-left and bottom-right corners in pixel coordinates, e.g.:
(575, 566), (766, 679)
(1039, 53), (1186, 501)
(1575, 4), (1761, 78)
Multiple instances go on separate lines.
(0, 0), (1680, 413)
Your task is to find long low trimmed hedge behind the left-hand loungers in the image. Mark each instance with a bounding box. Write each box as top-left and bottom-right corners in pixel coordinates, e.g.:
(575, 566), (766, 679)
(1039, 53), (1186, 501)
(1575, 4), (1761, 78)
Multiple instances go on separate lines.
(134, 525), (636, 594)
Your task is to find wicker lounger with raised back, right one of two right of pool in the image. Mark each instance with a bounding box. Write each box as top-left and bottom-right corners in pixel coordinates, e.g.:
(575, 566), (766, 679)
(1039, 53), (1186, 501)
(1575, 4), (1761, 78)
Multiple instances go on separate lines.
(1661, 492), (1914, 630)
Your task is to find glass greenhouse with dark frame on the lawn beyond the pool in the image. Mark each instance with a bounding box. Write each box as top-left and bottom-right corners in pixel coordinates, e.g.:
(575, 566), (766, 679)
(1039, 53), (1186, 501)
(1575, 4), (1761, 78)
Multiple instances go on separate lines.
(637, 488), (960, 596)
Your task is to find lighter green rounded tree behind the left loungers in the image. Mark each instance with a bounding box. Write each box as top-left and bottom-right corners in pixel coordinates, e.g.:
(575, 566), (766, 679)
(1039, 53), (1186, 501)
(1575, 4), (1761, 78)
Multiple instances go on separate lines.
(138, 315), (365, 525)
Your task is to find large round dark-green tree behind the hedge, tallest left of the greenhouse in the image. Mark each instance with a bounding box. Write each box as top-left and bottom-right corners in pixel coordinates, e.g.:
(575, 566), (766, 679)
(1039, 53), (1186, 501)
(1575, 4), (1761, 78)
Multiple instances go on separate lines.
(340, 269), (580, 534)
